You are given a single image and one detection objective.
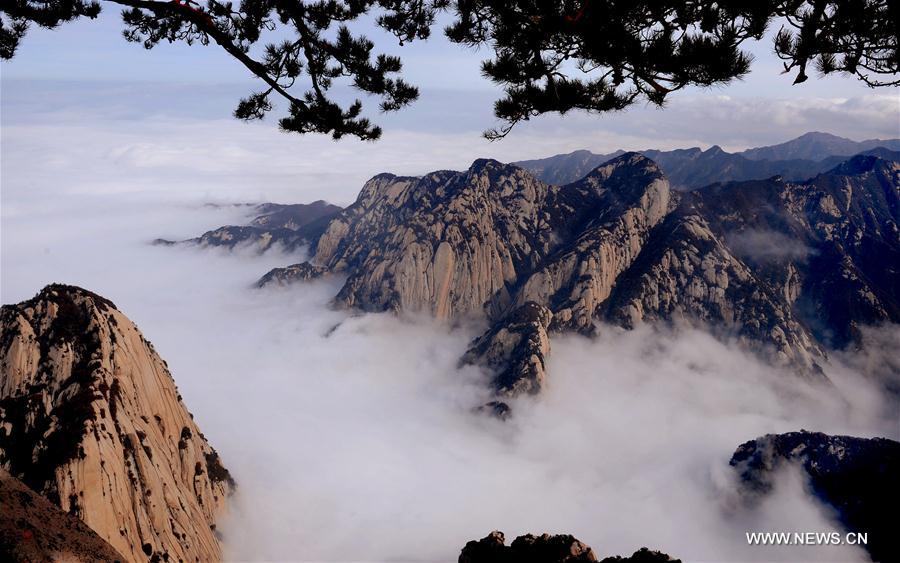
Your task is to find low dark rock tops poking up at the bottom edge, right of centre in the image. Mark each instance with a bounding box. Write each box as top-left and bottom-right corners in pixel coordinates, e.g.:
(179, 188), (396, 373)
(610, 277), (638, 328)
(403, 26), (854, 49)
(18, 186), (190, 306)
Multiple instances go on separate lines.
(459, 531), (681, 563)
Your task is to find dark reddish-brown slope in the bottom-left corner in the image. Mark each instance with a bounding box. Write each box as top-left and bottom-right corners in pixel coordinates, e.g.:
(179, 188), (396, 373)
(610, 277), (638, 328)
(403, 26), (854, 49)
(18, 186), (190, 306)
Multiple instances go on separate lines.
(0, 469), (126, 563)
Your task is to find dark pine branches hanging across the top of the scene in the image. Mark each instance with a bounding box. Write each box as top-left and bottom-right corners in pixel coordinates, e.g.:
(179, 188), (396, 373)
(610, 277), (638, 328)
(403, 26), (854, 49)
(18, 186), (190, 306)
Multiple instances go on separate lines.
(0, 0), (900, 139)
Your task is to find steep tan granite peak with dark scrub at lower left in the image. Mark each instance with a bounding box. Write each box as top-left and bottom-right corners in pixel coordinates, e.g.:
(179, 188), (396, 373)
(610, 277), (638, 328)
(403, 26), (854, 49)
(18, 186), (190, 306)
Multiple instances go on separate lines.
(0, 285), (234, 561)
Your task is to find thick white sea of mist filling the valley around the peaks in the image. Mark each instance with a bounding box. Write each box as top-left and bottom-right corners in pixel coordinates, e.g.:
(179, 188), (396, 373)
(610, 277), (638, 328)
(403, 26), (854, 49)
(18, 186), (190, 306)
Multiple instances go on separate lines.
(0, 183), (900, 561)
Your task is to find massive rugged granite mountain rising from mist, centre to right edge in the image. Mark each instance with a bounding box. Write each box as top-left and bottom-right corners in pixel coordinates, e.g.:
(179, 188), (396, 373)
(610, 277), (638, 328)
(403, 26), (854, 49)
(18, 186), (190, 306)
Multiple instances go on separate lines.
(250, 153), (900, 396)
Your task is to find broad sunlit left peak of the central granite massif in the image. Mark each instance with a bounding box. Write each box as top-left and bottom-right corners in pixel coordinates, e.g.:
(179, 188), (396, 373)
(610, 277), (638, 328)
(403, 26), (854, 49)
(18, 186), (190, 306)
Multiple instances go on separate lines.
(312, 160), (553, 318)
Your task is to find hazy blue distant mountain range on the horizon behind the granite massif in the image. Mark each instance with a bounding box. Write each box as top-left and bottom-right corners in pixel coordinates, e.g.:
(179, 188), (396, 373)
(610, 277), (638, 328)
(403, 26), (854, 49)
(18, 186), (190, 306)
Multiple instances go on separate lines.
(513, 133), (900, 190)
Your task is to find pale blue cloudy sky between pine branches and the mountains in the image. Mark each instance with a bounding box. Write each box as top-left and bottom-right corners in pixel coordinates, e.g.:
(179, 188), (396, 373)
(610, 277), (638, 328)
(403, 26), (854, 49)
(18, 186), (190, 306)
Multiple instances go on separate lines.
(0, 5), (900, 207)
